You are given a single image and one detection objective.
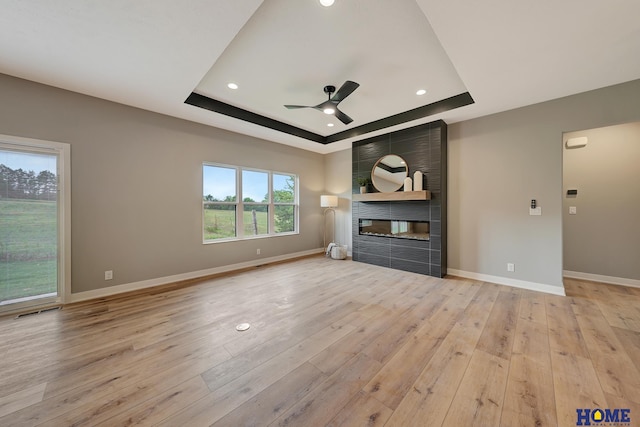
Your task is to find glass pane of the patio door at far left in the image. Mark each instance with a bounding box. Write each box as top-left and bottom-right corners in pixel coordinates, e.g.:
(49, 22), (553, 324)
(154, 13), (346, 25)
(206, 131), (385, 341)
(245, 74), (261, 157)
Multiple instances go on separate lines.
(0, 141), (61, 311)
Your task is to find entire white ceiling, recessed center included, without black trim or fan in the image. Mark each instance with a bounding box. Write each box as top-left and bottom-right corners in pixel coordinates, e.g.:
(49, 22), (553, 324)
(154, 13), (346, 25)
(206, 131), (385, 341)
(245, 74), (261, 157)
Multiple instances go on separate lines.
(0, 0), (640, 153)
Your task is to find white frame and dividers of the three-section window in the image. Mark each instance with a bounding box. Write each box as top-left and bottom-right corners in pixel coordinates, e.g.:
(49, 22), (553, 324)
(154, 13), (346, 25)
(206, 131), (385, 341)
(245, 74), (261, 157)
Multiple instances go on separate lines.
(200, 162), (300, 245)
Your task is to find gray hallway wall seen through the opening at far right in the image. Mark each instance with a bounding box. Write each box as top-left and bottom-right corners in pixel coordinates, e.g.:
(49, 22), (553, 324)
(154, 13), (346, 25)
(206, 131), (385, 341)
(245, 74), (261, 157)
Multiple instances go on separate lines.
(563, 122), (640, 280)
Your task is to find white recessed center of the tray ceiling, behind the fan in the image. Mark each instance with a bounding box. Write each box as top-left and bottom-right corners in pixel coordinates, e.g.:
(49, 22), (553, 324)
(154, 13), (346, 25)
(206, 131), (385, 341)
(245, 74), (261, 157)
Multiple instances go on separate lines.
(196, 0), (467, 136)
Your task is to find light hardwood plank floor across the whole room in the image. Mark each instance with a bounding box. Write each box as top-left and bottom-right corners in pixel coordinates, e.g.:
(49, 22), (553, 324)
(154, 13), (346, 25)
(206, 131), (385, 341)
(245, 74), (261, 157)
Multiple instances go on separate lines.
(0, 256), (640, 427)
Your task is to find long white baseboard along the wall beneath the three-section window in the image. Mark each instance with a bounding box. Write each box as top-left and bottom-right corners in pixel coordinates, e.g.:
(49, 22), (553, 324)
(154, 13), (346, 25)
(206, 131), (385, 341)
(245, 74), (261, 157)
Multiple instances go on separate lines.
(65, 248), (323, 303)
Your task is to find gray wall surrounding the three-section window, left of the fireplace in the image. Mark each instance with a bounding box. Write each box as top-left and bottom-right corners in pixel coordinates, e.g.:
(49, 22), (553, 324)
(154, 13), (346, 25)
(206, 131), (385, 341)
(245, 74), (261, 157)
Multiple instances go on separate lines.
(0, 75), (324, 293)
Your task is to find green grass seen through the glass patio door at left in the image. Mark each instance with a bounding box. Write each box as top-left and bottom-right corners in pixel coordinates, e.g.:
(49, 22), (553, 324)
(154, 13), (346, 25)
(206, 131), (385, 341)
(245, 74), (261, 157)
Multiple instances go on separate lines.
(0, 199), (58, 301)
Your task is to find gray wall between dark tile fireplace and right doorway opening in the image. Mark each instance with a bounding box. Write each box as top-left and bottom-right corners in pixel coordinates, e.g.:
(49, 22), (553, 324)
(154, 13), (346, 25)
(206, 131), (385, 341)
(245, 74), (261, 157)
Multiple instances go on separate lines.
(448, 80), (640, 287)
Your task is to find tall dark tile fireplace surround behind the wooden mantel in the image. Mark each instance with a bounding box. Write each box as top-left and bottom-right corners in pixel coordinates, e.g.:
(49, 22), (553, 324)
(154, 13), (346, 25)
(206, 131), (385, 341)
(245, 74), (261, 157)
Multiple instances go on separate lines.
(352, 120), (447, 277)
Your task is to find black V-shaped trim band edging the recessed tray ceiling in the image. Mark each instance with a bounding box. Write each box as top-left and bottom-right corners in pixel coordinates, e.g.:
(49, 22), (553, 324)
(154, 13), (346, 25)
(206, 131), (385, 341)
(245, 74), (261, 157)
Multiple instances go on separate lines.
(184, 92), (475, 145)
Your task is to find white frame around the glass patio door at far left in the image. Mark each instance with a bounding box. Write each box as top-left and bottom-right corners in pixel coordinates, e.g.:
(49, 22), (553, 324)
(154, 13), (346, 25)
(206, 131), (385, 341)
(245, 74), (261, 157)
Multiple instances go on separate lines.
(0, 134), (71, 315)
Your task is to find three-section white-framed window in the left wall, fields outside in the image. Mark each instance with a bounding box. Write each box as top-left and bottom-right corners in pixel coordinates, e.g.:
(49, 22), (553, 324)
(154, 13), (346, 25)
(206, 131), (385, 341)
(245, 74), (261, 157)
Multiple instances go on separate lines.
(202, 163), (298, 243)
